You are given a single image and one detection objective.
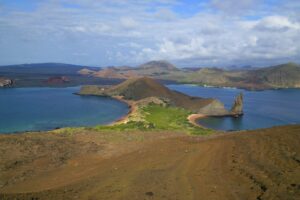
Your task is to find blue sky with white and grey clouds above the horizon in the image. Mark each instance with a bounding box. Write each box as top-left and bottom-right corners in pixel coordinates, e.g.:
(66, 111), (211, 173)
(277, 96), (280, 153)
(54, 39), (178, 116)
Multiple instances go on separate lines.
(0, 0), (300, 67)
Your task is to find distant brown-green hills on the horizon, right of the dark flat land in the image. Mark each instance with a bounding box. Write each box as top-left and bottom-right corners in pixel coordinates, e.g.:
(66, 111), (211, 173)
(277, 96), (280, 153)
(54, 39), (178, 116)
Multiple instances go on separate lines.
(79, 61), (300, 90)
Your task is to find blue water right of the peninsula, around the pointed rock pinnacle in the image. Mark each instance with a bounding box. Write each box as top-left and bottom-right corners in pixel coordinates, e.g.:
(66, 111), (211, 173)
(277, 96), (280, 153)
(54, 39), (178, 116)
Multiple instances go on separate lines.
(168, 85), (300, 130)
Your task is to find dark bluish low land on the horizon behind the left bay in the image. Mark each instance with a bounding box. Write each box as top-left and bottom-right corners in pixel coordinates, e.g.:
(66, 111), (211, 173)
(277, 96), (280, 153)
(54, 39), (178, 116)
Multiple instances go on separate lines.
(0, 63), (120, 87)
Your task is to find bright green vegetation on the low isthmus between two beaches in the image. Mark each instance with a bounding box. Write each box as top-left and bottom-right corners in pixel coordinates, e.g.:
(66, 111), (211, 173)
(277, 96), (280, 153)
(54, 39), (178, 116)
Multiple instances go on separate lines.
(93, 104), (212, 135)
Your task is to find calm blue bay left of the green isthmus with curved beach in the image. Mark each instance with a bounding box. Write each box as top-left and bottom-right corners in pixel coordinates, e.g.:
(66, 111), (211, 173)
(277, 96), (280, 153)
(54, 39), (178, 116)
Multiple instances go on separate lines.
(0, 87), (128, 133)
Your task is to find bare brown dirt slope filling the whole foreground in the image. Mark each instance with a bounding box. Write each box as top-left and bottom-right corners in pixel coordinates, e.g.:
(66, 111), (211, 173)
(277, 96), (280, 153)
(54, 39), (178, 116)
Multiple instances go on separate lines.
(0, 126), (300, 200)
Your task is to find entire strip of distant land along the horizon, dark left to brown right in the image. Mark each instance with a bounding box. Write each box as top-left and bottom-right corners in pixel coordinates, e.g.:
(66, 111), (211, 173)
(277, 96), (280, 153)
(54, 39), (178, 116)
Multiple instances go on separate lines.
(0, 61), (300, 90)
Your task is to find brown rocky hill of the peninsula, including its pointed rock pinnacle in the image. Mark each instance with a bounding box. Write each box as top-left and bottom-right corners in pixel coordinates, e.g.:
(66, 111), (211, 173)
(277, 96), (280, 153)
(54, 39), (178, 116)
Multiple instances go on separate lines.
(79, 77), (243, 116)
